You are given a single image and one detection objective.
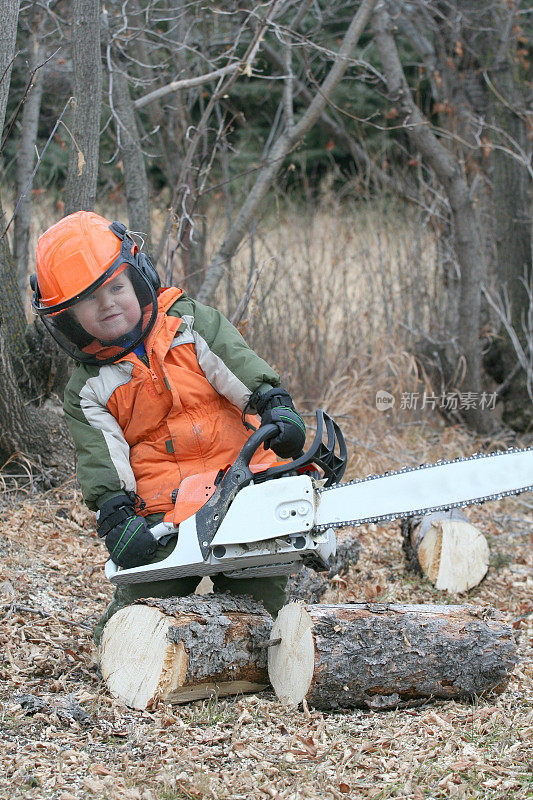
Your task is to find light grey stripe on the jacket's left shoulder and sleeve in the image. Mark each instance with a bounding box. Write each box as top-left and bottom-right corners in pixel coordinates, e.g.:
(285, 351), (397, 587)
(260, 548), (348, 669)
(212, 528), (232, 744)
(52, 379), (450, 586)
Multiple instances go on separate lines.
(80, 362), (137, 492)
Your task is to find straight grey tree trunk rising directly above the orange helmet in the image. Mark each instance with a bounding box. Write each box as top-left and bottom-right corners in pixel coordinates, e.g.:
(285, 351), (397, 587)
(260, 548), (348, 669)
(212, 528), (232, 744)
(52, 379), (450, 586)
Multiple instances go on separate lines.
(65, 0), (102, 214)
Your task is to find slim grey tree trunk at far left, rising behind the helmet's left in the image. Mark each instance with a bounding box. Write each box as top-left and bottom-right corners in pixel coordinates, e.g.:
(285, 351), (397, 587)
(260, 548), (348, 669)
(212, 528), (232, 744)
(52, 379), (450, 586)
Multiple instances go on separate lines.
(13, 24), (45, 304)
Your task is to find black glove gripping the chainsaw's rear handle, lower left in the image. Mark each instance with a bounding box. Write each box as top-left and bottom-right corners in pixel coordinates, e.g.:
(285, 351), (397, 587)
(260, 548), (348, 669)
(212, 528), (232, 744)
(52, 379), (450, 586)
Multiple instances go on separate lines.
(96, 494), (157, 569)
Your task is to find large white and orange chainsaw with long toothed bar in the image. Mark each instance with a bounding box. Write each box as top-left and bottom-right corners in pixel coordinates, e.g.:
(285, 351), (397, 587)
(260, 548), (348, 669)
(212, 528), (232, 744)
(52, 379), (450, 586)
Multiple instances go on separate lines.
(106, 409), (533, 585)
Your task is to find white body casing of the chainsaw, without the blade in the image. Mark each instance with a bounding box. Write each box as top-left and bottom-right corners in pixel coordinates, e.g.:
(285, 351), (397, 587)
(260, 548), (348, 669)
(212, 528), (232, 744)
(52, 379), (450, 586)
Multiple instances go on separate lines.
(106, 475), (335, 585)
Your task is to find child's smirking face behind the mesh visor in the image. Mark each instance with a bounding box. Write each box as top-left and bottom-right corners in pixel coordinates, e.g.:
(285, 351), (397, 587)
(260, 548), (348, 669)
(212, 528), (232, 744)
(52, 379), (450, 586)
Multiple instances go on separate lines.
(72, 272), (141, 342)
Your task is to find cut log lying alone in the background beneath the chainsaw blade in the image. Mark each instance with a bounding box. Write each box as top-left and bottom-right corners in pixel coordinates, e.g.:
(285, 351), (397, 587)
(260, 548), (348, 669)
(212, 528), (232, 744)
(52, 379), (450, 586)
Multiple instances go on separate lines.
(402, 508), (490, 594)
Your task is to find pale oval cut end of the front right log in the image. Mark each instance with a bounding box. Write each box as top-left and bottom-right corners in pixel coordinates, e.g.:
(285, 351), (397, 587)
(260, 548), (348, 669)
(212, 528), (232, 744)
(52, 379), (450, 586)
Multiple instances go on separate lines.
(268, 603), (315, 706)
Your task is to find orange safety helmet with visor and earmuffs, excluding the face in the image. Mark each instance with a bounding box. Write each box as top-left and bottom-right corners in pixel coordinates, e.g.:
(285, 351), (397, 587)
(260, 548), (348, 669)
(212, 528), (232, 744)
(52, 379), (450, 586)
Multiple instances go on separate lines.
(30, 211), (160, 365)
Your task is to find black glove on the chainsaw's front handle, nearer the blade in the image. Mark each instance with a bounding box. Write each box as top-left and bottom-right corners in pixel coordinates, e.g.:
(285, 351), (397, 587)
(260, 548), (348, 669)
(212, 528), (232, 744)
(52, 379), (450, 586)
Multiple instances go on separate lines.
(250, 389), (305, 458)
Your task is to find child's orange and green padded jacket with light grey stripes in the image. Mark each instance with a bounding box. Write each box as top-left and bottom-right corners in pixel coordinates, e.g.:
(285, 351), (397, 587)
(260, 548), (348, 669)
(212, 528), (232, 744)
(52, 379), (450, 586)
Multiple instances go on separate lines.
(63, 288), (280, 515)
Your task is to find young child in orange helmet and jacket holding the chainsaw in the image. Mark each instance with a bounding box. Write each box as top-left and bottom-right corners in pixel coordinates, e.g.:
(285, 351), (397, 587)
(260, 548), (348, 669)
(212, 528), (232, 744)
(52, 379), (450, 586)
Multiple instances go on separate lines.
(31, 211), (305, 643)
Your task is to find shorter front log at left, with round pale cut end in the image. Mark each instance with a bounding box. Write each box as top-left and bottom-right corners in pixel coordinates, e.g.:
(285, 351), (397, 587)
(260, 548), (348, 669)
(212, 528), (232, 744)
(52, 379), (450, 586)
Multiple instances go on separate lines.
(99, 594), (272, 709)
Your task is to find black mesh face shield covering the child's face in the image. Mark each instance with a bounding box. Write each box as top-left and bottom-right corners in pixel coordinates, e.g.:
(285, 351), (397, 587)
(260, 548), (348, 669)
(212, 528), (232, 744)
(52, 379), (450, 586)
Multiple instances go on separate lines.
(32, 223), (159, 366)
